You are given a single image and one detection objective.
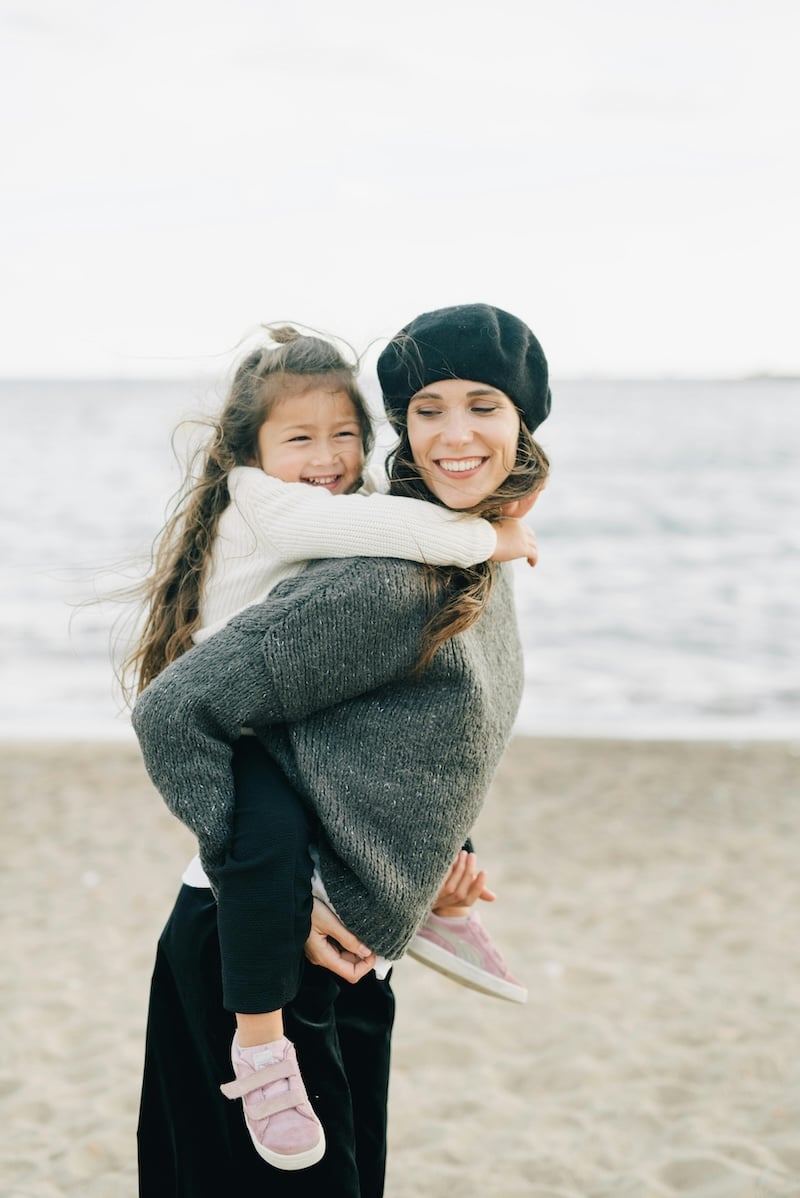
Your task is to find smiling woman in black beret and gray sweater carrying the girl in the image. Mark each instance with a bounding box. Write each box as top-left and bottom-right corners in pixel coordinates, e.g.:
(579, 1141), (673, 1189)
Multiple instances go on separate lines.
(134, 304), (550, 1198)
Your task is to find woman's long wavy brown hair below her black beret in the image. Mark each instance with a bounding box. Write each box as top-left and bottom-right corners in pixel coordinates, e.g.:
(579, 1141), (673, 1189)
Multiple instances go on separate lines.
(387, 413), (550, 674)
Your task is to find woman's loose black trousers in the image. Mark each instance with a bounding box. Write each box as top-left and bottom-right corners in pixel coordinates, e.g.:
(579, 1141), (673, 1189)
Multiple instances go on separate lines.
(138, 887), (394, 1198)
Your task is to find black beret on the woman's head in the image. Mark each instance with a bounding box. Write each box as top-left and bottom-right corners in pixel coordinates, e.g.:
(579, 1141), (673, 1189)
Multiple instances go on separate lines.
(377, 303), (550, 432)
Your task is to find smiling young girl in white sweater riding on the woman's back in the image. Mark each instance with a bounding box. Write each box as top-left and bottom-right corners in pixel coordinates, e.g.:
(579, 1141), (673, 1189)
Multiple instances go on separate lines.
(128, 328), (537, 1169)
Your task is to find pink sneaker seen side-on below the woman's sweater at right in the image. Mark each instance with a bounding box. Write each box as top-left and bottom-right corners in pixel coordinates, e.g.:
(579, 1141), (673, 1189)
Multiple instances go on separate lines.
(406, 910), (528, 1003)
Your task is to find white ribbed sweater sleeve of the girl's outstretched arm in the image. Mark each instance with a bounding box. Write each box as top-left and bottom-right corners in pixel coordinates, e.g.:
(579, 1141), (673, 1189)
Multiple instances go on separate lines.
(230, 466), (497, 567)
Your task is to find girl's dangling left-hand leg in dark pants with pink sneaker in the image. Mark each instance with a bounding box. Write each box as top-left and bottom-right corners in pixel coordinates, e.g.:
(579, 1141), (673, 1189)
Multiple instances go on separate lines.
(217, 737), (325, 1170)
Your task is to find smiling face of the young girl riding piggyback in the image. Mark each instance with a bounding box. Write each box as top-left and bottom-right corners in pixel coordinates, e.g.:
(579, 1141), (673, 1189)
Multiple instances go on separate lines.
(257, 387), (364, 495)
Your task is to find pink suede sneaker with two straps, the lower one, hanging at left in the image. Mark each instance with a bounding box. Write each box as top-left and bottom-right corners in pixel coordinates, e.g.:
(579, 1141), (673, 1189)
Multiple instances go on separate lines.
(219, 1036), (325, 1169)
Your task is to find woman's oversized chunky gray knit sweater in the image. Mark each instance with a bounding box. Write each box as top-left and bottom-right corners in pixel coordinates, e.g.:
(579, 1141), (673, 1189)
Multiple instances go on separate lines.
(133, 557), (522, 958)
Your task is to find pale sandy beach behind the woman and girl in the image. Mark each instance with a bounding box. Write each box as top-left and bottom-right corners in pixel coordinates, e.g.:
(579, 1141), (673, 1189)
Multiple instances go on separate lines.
(0, 738), (800, 1198)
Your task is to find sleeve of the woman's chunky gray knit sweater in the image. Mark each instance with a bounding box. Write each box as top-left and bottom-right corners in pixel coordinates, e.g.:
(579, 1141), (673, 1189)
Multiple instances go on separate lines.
(133, 558), (430, 883)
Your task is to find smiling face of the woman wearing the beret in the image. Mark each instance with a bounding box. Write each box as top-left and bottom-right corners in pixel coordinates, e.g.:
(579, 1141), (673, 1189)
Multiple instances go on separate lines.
(407, 379), (520, 510)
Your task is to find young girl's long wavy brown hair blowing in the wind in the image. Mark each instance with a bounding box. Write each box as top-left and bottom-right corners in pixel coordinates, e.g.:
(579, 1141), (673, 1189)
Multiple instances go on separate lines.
(121, 326), (374, 698)
